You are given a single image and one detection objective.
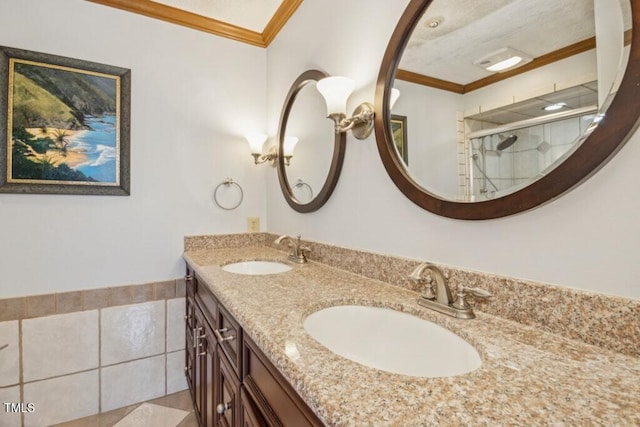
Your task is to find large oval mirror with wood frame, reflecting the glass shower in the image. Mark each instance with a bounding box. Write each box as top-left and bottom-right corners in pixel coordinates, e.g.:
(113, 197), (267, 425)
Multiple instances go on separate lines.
(375, 0), (640, 219)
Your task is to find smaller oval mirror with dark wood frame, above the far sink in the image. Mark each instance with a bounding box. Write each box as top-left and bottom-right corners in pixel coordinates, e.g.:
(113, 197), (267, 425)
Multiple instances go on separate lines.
(278, 70), (346, 213)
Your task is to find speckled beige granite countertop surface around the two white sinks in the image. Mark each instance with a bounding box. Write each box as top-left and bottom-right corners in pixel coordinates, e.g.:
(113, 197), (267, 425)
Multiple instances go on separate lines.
(184, 246), (640, 426)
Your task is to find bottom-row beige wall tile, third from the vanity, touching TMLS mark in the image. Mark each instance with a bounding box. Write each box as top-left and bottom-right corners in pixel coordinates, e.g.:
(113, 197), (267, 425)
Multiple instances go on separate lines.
(23, 369), (100, 427)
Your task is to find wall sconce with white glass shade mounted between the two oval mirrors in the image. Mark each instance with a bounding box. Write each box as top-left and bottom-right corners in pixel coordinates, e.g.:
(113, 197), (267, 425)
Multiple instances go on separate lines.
(316, 76), (374, 139)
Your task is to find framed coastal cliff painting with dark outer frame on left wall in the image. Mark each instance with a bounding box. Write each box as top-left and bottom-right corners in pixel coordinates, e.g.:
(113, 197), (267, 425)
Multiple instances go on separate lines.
(0, 46), (131, 196)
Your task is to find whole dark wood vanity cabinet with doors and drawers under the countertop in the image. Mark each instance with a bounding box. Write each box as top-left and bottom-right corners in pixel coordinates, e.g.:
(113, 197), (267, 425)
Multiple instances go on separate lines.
(184, 267), (323, 427)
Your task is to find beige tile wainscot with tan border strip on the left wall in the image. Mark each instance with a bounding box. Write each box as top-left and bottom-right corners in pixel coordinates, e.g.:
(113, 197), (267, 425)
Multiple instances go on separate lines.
(0, 280), (187, 427)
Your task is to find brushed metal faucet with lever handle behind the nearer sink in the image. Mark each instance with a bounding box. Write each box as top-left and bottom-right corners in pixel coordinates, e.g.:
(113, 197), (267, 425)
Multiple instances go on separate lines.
(409, 263), (491, 319)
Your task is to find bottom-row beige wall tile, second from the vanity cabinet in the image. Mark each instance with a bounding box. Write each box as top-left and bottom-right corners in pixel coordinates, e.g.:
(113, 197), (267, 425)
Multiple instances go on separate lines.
(101, 354), (165, 411)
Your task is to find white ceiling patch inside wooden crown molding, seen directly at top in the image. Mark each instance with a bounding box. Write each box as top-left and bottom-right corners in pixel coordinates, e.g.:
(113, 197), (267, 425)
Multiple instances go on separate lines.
(154, 0), (282, 33)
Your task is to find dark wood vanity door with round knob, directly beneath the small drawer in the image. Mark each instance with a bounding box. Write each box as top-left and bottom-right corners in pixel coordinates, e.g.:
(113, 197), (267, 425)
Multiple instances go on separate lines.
(215, 346), (240, 427)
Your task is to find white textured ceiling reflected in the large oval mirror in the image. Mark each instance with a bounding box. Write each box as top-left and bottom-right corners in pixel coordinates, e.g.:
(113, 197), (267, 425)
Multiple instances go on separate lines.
(400, 0), (595, 85)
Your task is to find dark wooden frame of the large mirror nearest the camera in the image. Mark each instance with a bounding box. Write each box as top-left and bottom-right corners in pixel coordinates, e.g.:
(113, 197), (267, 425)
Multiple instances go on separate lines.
(375, 0), (640, 220)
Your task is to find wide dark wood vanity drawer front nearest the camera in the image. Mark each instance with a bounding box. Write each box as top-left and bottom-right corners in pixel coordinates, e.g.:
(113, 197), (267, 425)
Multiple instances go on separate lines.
(242, 336), (323, 427)
